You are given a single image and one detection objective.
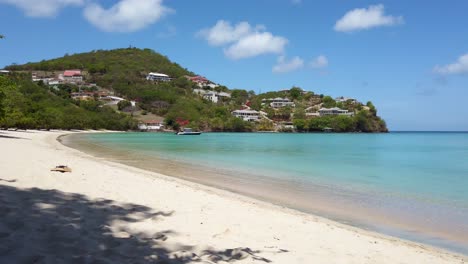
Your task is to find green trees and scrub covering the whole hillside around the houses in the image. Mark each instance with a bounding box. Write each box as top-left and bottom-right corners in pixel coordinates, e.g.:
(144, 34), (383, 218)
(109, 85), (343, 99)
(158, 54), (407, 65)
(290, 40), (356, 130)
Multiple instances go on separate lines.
(0, 48), (387, 132)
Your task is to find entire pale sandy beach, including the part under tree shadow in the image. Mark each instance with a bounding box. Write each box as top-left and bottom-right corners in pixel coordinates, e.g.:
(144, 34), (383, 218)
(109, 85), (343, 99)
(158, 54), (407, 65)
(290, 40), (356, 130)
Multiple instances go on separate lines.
(0, 131), (468, 263)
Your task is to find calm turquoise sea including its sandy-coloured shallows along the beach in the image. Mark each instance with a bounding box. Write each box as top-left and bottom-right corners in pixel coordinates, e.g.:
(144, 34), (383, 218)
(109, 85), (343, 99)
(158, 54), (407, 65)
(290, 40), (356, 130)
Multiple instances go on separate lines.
(64, 132), (468, 254)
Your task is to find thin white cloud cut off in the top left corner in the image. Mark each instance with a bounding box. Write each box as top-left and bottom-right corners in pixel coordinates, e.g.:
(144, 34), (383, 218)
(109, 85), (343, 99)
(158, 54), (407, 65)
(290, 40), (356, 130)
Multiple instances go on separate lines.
(0, 0), (85, 17)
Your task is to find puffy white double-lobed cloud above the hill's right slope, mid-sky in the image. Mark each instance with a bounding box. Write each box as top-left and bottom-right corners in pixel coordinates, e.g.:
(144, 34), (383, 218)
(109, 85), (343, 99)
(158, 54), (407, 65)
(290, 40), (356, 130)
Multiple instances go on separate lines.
(197, 20), (288, 60)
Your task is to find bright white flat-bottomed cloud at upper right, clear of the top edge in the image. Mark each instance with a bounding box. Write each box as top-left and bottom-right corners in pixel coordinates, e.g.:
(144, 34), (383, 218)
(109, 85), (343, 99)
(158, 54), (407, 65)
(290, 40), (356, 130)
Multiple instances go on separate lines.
(335, 4), (404, 32)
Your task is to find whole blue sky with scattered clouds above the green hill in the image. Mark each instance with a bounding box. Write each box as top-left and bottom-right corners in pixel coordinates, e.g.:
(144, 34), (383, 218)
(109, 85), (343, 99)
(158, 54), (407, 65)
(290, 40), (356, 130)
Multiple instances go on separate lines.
(0, 0), (468, 131)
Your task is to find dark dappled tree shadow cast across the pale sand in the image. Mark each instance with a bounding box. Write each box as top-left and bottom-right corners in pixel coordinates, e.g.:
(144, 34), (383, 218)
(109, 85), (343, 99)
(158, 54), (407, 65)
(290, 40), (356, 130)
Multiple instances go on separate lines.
(0, 185), (271, 264)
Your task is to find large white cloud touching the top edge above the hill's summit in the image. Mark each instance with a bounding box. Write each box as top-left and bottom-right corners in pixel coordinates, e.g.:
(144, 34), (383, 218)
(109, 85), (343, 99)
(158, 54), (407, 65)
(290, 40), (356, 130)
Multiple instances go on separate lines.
(84, 0), (173, 32)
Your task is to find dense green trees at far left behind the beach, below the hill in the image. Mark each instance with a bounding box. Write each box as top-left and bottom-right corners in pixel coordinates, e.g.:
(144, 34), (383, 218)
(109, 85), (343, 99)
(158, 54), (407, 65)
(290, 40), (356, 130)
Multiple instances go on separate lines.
(0, 75), (136, 130)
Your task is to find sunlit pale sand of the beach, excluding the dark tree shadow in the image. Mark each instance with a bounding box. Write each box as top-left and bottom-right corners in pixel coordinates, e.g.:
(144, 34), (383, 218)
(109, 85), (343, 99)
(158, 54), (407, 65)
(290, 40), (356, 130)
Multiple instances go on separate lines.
(0, 131), (467, 263)
